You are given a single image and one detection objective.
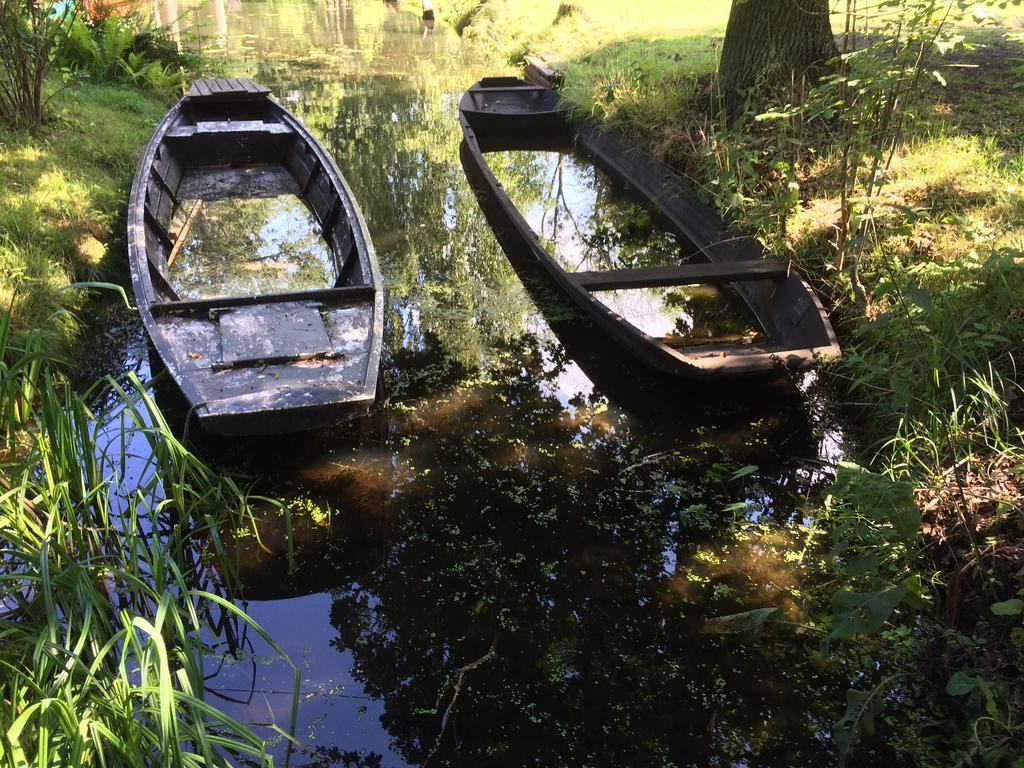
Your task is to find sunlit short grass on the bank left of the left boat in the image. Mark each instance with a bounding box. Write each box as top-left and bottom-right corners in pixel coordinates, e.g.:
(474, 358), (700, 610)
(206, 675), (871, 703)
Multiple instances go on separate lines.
(0, 84), (167, 349)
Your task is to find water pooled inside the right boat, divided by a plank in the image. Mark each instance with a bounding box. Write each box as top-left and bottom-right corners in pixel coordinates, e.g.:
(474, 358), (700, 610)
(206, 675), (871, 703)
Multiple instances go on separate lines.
(487, 151), (765, 346)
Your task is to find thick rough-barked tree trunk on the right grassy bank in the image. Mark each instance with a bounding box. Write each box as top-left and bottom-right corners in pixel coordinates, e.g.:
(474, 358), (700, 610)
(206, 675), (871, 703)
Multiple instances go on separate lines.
(718, 0), (837, 119)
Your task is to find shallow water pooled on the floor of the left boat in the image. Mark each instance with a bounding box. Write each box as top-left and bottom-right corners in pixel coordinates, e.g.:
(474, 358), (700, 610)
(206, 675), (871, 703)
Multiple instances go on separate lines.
(168, 167), (336, 300)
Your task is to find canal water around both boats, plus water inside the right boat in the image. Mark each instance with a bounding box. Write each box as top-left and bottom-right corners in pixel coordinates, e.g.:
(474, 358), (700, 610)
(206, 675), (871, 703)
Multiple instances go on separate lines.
(83, 0), (850, 768)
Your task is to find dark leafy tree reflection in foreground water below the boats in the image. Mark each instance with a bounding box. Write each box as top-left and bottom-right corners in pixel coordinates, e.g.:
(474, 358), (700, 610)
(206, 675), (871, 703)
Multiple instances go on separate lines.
(309, 345), (845, 766)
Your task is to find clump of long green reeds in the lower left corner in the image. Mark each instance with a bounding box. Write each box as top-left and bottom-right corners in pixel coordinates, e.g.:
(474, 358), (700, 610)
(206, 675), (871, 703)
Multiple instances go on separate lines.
(0, 315), (299, 767)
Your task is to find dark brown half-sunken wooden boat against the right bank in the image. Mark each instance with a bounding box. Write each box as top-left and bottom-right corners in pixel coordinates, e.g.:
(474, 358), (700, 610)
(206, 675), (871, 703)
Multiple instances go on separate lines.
(460, 78), (840, 382)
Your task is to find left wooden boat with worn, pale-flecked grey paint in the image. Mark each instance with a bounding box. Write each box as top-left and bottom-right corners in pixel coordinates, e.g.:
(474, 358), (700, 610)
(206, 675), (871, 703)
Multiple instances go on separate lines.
(128, 78), (383, 434)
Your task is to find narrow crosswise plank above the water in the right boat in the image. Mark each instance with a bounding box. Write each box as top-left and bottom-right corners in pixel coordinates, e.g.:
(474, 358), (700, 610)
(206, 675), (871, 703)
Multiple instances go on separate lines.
(570, 259), (790, 291)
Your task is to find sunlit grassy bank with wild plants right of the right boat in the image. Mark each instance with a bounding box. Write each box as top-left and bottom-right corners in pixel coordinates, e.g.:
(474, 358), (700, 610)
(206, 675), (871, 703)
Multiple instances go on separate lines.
(458, 0), (1024, 768)
